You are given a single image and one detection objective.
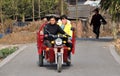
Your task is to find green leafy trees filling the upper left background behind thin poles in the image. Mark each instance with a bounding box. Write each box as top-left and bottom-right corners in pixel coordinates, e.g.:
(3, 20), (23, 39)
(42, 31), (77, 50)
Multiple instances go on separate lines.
(0, 0), (67, 21)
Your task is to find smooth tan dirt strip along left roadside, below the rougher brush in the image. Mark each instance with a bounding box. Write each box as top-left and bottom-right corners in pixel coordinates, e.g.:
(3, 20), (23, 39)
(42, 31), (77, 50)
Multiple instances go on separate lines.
(0, 31), (36, 44)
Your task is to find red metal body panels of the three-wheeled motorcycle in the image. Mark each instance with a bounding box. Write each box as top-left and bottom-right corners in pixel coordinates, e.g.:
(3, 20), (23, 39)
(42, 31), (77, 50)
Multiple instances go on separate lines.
(37, 23), (75, 62)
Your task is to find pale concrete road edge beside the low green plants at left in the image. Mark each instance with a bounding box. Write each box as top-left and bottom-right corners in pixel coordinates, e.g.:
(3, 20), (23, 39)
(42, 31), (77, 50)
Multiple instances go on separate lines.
(0, 46), (27, 68)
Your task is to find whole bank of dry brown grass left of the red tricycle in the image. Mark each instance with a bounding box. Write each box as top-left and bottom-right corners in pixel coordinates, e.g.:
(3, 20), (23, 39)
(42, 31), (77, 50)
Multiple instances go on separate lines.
(0, 21), (44, 44)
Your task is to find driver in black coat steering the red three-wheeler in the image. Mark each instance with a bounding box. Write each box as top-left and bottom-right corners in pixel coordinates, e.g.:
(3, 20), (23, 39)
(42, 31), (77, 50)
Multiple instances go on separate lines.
(44, 16), (66, 47)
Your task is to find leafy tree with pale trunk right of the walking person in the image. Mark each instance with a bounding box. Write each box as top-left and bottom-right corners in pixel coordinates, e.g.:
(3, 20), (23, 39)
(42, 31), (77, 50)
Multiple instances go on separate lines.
(101, 0), (120, 39)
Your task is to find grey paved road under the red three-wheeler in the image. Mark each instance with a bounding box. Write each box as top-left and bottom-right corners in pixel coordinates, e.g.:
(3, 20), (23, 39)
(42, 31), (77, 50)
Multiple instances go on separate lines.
(0, 39), (120, 76)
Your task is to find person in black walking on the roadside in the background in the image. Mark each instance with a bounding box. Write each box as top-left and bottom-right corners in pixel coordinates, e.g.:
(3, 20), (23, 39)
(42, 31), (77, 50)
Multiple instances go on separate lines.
(90, 9), (107, 39)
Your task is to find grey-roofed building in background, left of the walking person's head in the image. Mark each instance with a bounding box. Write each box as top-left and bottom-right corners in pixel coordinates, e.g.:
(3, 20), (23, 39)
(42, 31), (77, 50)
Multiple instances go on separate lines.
(68, 0), (101, 18)
